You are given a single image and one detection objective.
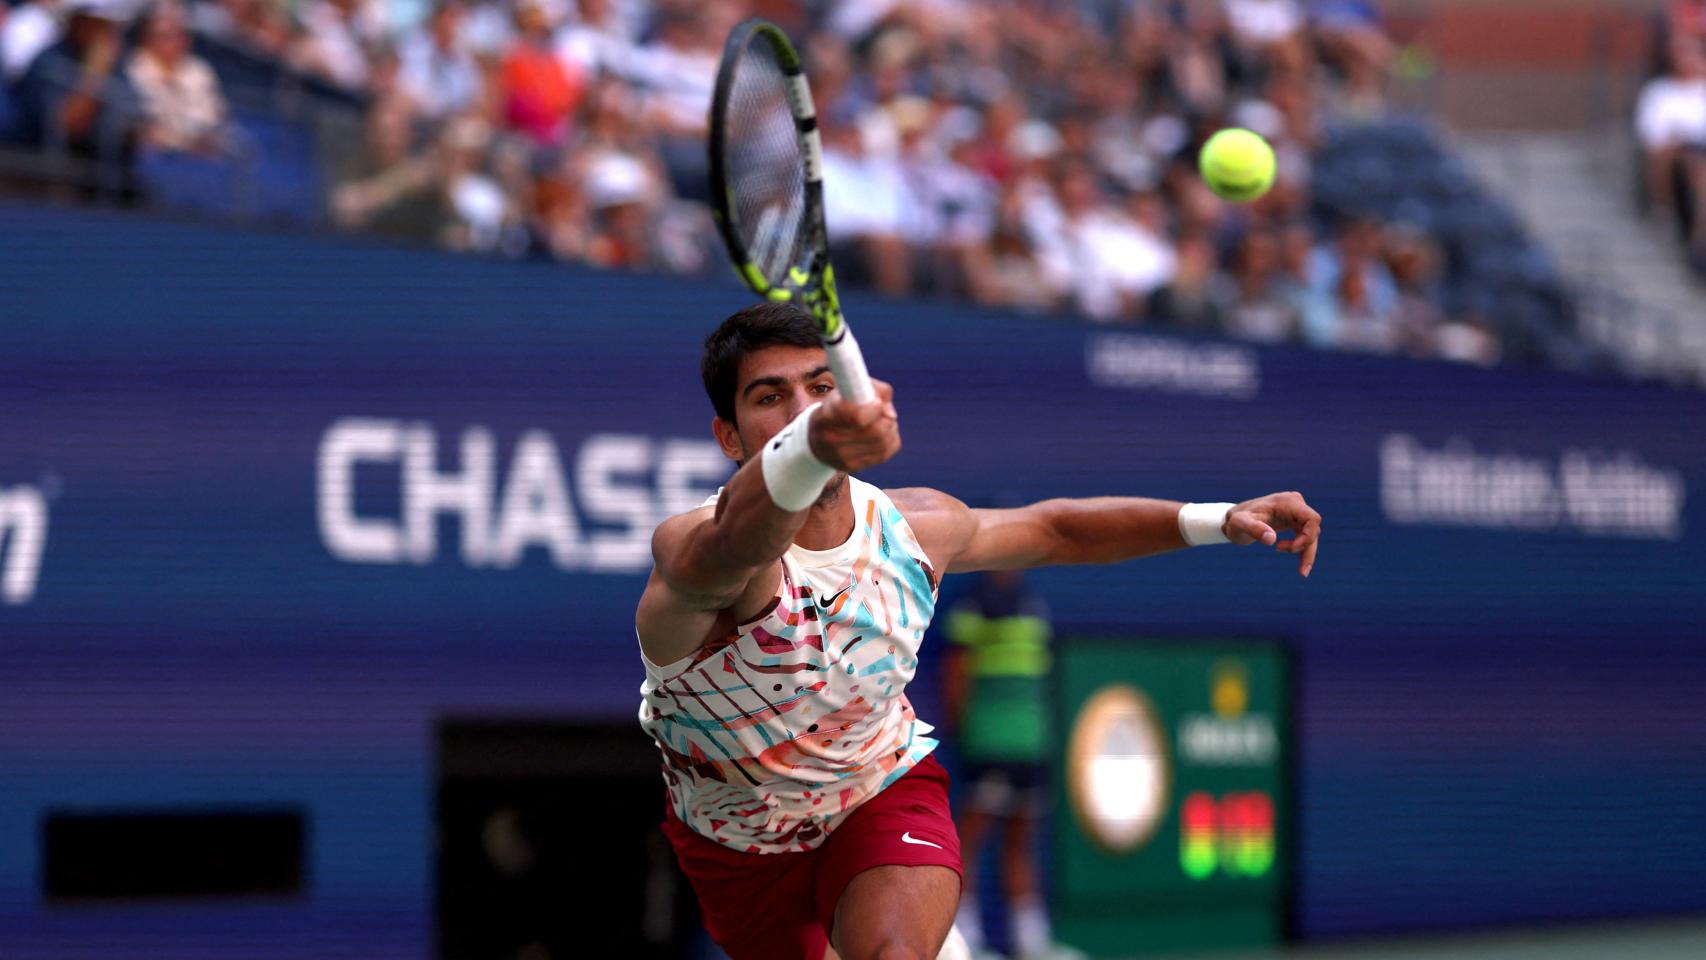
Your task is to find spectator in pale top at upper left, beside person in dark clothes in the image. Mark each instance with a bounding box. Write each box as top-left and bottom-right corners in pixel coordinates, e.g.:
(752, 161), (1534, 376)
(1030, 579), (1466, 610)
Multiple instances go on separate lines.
(126, 3), (227, 155)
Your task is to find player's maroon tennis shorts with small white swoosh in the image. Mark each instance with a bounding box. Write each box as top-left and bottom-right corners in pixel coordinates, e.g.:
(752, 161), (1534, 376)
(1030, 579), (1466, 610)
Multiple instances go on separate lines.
(664, 757), (964, 960)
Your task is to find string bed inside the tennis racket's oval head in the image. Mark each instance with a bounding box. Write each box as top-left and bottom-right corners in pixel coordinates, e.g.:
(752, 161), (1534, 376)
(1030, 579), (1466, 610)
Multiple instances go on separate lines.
(723, 38), (809, 286)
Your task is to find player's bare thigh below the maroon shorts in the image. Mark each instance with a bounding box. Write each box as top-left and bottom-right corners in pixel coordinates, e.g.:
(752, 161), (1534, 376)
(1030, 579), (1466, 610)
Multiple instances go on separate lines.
(829, 866), (960, 960)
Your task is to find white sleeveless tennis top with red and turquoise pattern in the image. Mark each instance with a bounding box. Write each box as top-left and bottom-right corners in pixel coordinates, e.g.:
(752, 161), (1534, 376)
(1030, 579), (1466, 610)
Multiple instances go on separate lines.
(640, 479), (937, 853)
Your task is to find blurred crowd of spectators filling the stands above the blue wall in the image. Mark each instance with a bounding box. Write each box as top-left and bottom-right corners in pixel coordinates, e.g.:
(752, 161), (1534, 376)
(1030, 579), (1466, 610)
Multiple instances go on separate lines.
(0, 0), (1501, 363)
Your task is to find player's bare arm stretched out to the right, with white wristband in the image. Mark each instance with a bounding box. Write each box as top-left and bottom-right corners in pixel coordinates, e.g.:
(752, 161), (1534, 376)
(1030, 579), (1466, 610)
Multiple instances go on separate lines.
(891, 488), (1320, 576)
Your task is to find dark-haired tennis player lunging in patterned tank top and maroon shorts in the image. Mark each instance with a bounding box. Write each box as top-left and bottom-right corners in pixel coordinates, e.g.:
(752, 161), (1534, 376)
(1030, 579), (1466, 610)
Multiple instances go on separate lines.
(635, 304), (1320, 960)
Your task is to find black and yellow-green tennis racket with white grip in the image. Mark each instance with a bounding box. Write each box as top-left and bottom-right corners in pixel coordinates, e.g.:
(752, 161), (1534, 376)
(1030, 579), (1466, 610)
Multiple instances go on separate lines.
(710, 17), (877, 402)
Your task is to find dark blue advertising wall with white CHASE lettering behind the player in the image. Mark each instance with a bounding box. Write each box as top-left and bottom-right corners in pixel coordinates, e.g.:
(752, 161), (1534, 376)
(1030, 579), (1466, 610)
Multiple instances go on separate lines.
(0, 205), (1706, 958)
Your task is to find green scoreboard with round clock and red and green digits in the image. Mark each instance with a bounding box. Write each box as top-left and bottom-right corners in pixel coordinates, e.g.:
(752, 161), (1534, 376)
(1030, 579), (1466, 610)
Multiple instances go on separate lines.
(1053, 639), (1291, 957)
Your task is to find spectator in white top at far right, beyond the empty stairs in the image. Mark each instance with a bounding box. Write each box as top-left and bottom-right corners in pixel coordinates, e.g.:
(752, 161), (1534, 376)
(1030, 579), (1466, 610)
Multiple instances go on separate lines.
(1634, 34), (1706, 275)
